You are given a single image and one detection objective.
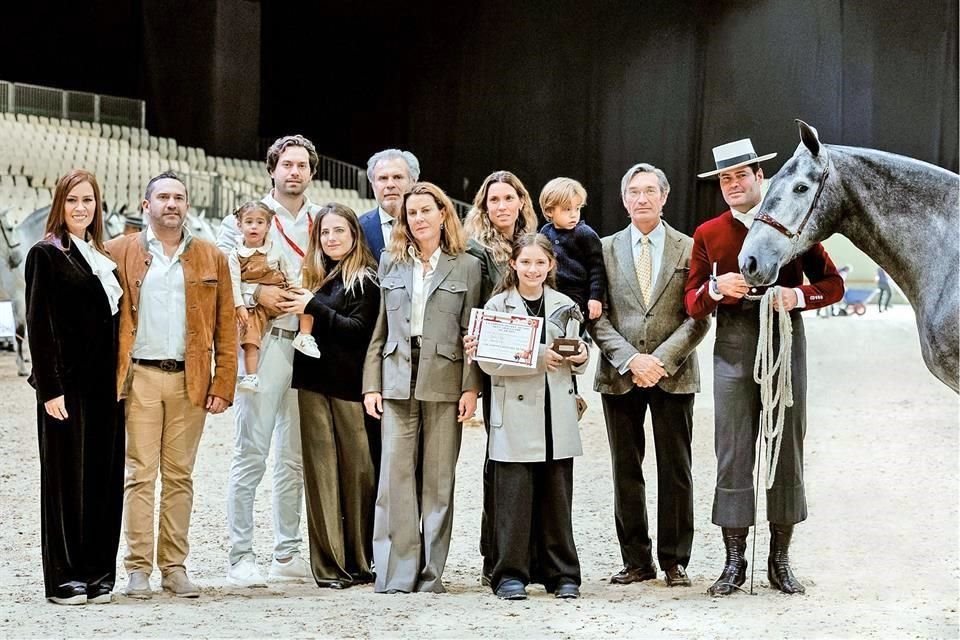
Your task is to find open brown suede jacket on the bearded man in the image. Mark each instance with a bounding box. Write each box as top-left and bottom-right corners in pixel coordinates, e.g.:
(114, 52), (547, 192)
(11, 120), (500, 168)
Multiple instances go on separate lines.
(106, 232), (237, 407)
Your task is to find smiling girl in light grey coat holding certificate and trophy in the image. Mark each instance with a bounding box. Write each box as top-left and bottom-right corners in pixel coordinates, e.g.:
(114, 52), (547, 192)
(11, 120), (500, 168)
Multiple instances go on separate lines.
(464, 234), (589, 600)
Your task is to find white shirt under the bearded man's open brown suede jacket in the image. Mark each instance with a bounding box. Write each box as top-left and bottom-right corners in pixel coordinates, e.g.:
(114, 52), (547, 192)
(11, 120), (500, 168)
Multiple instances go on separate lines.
(133, 225), (190, 361)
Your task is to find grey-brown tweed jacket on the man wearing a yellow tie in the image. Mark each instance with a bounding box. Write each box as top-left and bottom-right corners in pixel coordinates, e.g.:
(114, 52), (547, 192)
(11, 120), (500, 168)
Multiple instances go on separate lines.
(590, 222), (710, 395)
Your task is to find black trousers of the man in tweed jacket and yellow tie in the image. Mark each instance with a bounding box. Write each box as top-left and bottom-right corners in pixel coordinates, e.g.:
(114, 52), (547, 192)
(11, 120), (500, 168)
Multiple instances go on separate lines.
(601, 387), (693, 569)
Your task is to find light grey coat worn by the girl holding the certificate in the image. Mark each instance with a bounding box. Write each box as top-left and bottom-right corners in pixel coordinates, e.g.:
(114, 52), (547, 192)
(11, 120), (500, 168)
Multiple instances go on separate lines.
(479, 287), (587, 462)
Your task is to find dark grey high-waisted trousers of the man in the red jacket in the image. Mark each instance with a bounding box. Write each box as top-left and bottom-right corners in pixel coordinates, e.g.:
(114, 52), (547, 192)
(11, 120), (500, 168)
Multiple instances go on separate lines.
(713, 302), (807, 528)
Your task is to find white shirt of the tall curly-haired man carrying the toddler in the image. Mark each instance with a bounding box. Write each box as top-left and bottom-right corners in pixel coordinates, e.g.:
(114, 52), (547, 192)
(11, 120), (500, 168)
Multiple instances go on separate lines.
(217, 191), (320, 330)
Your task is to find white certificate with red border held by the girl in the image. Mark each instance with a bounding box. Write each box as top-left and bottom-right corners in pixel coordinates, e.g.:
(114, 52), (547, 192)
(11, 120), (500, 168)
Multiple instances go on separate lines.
(470, 309), (543, 369)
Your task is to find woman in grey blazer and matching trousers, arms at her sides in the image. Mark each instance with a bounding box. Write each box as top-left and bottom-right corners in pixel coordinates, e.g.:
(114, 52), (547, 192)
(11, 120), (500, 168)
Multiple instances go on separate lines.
(363, 182), (480, 593)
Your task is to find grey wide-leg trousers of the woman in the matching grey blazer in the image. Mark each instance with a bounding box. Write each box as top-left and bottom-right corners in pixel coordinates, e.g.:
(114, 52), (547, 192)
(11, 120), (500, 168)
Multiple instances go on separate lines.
(373, 358), (462, 593)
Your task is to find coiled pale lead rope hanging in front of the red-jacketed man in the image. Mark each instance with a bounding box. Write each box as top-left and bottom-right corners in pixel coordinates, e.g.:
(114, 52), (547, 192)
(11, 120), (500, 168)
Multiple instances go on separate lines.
(753, 287), (793, 489)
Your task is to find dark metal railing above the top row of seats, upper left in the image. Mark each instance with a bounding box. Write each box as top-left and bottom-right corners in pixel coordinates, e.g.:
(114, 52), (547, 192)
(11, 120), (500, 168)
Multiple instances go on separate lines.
(0, 80), (147, 129)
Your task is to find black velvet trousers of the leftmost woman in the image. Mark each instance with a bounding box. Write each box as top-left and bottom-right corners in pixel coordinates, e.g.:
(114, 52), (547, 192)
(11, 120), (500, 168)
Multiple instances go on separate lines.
(37, 392), (125, 597)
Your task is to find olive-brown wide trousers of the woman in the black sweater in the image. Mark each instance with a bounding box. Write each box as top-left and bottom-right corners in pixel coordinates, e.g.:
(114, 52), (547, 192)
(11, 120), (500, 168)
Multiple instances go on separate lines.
(298, 389), (376, 585)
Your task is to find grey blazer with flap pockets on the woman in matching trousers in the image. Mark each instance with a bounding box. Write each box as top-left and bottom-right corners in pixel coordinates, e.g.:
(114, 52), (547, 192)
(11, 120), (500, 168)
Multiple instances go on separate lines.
(363, 253), (480, 402)
